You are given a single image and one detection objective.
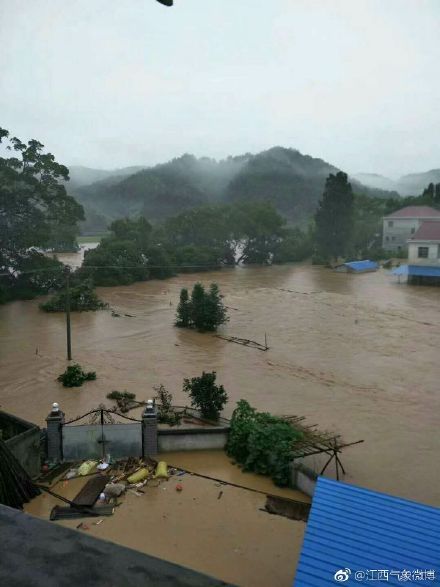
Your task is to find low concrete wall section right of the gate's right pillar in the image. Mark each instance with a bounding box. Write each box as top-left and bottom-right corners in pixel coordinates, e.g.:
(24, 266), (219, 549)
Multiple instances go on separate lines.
(158, 426), (229, 453)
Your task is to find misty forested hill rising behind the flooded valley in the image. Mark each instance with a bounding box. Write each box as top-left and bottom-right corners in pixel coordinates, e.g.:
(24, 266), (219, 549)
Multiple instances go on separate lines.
(67, 147), (398, 232)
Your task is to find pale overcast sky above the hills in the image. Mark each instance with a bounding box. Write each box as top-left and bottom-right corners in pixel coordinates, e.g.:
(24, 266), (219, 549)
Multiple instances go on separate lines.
(0, 0), (440, 176)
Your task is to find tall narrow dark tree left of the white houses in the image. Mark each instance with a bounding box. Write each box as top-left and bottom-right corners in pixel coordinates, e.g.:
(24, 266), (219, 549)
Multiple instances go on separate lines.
(315, 171), (354, 259)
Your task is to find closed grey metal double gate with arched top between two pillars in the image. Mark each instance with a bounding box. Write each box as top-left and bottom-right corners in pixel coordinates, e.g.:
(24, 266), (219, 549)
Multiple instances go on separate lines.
(62, 406), (143, 461)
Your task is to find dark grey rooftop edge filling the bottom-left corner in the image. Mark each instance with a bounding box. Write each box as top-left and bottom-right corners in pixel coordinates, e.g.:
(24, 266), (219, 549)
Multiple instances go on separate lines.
(0, 505), (234, 587)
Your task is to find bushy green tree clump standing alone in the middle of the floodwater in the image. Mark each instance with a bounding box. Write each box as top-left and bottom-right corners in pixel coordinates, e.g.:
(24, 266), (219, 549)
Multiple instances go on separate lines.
(175, 283), (228, 332)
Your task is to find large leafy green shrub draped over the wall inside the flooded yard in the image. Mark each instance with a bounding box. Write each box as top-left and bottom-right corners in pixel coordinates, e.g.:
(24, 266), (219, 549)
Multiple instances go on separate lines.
(226, 400), (303, 486)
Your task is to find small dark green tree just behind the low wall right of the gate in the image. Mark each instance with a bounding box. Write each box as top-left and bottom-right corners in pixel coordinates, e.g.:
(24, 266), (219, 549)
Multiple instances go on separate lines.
(183, 371), (228, 421)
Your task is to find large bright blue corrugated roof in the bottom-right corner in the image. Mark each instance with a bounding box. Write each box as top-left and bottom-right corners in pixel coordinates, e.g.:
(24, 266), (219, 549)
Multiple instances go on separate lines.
(294, 477), (440, 587)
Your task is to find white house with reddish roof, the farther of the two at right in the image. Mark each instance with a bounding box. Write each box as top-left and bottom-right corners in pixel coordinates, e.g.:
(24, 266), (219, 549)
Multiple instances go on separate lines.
(382, 206), (440, 251)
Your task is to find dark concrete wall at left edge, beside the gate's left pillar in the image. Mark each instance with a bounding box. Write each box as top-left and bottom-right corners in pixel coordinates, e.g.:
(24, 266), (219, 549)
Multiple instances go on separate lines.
(0, 412), (41, 477)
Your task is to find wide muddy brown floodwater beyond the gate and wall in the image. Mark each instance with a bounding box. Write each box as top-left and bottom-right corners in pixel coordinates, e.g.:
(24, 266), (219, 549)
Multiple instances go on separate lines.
(0, 265), (440, 505)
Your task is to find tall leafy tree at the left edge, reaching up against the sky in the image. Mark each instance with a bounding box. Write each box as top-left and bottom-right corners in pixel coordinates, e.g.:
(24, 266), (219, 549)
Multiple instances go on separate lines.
(0, 128), (84, 299)
